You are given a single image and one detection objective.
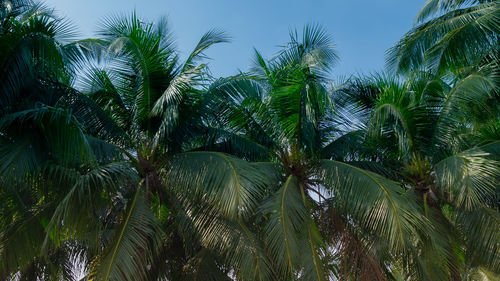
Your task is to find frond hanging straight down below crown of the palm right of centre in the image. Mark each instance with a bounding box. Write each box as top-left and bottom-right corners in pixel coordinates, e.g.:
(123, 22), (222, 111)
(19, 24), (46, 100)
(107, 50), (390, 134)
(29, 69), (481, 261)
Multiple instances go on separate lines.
(261, 175), (328, 280)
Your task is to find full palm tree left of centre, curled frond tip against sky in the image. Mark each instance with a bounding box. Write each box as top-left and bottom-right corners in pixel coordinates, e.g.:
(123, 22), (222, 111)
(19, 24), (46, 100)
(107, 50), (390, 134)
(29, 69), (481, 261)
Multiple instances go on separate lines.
(54, 10), (276, 280)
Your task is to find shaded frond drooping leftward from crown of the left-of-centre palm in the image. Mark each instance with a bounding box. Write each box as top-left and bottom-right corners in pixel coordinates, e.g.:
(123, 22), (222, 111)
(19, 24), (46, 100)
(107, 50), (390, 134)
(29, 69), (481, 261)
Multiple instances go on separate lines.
(43, 162), (138, 251)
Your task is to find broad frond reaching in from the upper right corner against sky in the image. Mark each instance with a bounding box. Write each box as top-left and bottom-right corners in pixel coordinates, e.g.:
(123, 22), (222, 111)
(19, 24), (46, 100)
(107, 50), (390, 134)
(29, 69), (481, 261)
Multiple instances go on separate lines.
(388, 1), (500, 72)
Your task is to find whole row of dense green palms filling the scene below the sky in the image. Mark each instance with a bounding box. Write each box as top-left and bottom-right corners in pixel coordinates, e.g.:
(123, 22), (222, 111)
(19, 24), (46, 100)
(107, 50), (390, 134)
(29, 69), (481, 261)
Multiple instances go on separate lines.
(0, 0), (500, 281)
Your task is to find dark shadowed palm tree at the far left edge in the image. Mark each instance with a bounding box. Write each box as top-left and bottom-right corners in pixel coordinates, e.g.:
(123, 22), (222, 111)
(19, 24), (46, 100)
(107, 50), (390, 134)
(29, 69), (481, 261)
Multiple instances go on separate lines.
(0, 1), (139, 280)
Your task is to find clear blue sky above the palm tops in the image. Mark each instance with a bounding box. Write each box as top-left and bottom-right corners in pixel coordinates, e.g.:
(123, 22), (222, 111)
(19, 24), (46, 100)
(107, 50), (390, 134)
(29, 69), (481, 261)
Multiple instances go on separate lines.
(45, 0), (425, 76)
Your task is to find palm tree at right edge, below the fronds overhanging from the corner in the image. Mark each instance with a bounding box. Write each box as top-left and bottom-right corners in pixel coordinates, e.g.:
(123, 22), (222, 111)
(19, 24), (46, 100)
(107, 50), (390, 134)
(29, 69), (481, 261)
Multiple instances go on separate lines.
(340, 67), (500, 280)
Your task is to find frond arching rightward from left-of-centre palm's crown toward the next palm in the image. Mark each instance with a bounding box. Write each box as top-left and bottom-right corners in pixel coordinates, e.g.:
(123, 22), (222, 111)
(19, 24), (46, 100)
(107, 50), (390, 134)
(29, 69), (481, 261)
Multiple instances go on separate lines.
(165, 152), (272, 218)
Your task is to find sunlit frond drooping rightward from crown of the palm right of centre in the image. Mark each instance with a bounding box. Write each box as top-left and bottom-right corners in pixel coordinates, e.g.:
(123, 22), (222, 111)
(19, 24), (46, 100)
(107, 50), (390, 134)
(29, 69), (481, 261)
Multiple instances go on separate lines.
(320, 160), (430, 251)
